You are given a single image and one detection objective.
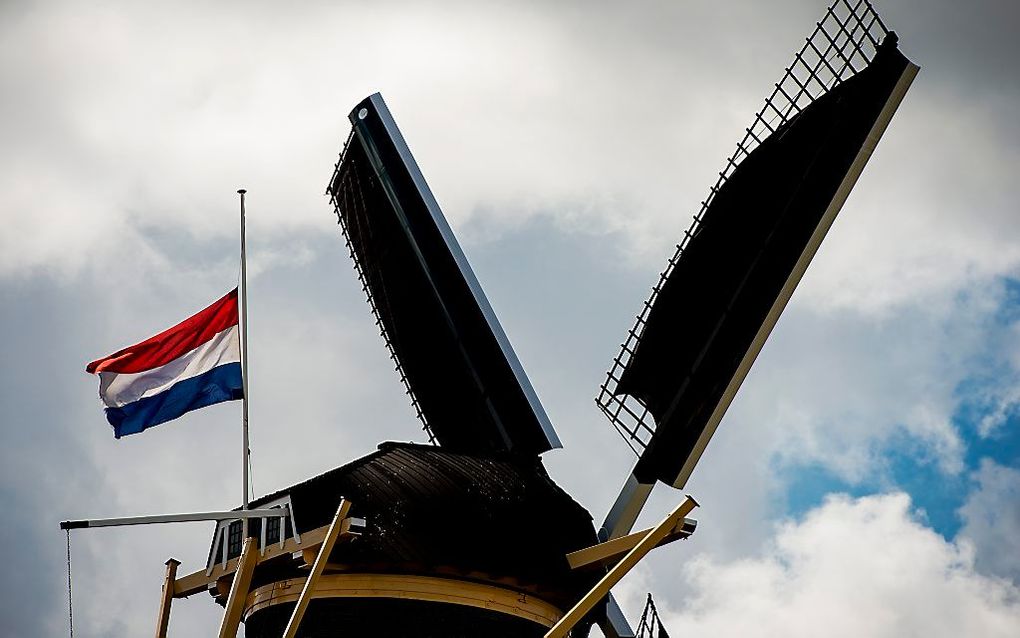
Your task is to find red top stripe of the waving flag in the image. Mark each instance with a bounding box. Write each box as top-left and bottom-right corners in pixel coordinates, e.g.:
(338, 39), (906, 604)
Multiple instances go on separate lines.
(85, 288), (238, 374)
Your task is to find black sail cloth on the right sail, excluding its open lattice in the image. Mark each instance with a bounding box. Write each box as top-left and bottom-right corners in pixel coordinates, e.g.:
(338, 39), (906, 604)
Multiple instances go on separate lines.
(616, 34), (910, 484)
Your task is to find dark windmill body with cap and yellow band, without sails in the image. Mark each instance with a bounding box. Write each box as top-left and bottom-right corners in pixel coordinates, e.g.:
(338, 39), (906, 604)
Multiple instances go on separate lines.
(227, 443), (597, 638)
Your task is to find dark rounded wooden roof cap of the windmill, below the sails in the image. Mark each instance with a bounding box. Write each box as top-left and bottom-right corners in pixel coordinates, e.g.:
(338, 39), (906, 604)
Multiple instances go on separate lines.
(241, 443), (598, 603)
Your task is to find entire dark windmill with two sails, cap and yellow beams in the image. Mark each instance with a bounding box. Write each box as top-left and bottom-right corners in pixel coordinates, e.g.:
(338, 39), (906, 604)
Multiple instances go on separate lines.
(59, 0), (918, 638)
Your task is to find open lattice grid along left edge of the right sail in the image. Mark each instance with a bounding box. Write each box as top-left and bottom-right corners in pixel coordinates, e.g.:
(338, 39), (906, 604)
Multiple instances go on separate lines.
(596, 0), (888, 455)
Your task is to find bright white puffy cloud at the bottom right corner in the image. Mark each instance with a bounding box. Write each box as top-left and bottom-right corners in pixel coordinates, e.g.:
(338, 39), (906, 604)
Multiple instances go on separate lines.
(659, 494), (1020, 638)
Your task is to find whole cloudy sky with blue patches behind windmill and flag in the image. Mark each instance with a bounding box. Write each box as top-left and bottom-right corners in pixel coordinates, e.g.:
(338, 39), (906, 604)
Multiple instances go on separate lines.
(0, 0), (1020, 637)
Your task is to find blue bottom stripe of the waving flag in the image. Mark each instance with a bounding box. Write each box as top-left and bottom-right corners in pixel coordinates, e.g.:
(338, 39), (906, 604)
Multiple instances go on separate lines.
(106, 362), (244, 439)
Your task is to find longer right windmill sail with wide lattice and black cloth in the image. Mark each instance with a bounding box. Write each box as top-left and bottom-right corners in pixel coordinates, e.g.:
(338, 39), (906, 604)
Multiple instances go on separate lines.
(598, 0), (918, 487)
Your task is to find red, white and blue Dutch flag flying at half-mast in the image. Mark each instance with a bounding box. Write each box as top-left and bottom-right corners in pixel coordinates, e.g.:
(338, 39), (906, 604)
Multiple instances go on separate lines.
(85, 288), (244, 439)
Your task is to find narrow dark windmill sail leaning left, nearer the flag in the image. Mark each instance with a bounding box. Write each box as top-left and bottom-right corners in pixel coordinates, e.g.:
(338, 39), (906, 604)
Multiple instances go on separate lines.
(327, 93), (560, 455)
